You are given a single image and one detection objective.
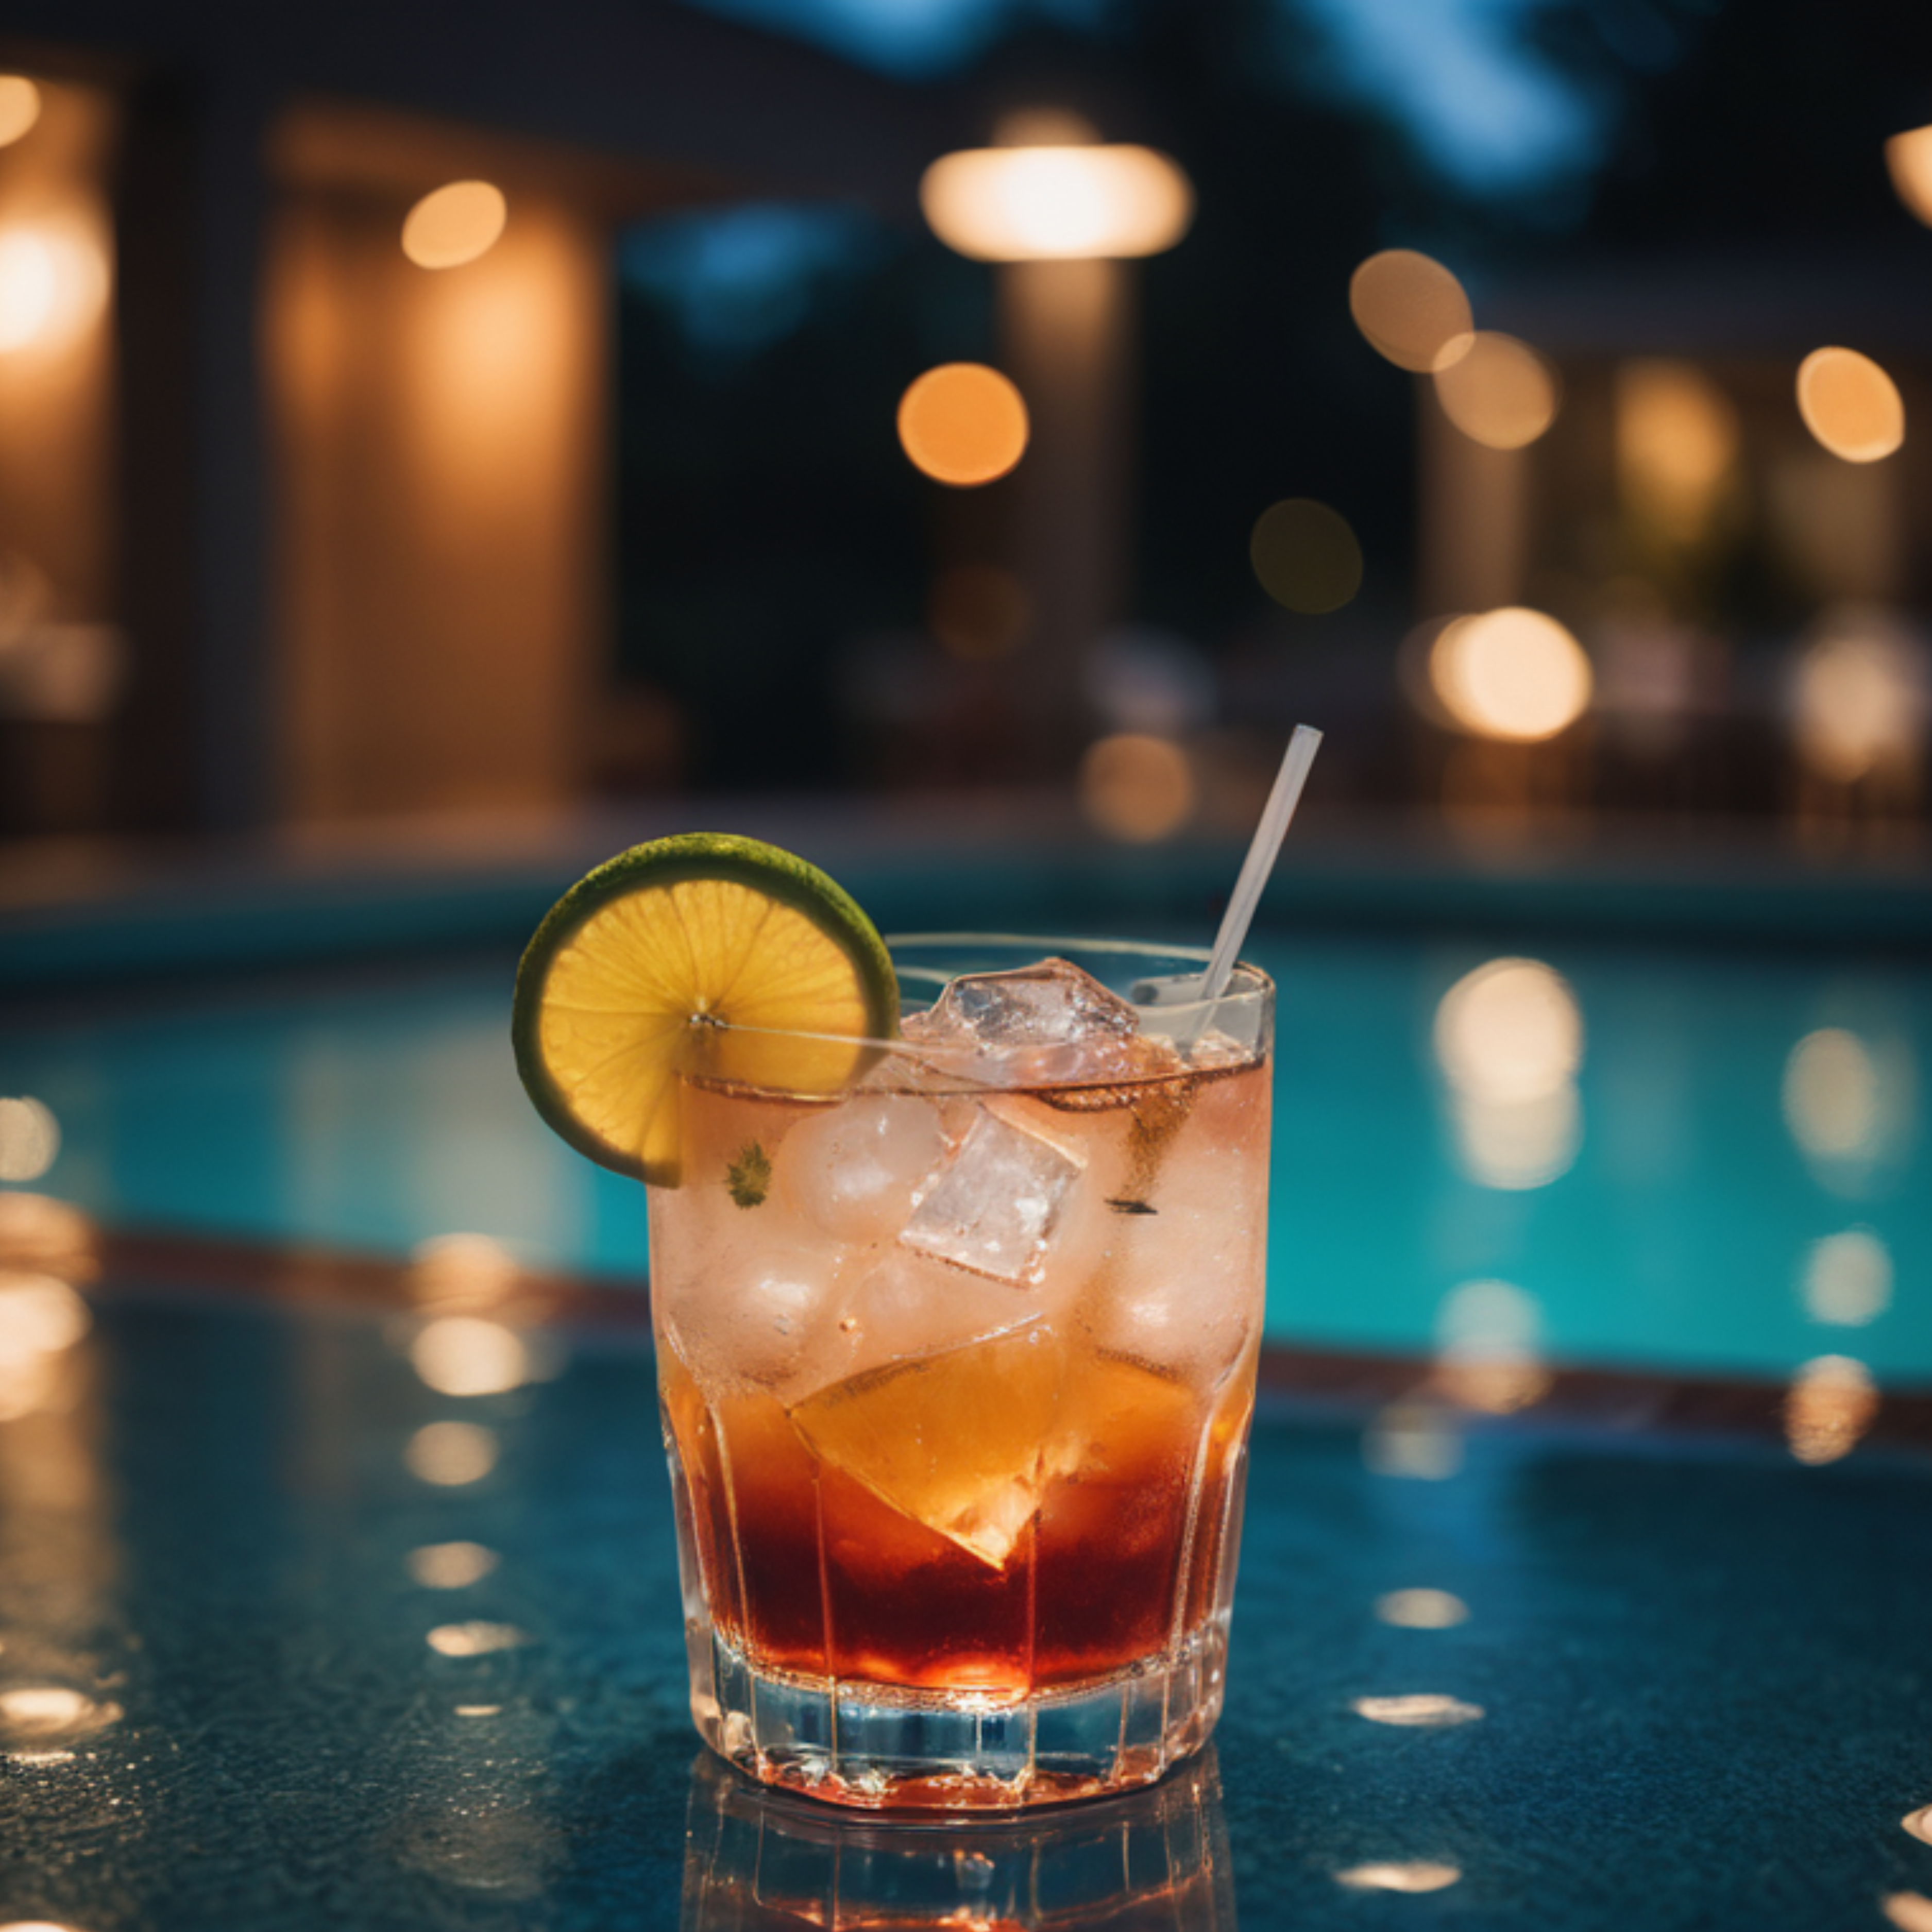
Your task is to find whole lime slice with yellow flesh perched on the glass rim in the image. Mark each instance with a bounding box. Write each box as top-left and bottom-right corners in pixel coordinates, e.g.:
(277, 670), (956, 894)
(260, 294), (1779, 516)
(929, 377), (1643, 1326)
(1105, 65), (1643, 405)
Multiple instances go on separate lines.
(510, 833), (899, 1187)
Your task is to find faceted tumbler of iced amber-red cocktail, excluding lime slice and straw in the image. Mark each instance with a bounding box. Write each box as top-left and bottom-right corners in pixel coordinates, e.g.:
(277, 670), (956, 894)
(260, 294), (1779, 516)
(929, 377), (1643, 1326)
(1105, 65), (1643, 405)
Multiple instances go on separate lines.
(651, 941), (1273, 1808)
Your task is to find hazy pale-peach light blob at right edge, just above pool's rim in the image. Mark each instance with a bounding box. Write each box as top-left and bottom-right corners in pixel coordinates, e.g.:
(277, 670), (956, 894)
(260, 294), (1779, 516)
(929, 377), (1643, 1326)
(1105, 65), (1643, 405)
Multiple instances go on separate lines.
(1791, 608), (1932, 785)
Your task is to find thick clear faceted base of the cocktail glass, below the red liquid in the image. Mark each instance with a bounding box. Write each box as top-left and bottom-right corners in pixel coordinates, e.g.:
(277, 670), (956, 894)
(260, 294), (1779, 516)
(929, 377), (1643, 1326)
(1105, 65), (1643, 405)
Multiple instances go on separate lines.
(686, 1615), (1227, 1810)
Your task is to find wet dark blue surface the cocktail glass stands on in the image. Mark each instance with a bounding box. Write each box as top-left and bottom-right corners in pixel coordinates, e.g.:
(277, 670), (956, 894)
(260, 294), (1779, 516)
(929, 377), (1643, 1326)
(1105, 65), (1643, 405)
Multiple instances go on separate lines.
(0, 1267), (1932, 1932)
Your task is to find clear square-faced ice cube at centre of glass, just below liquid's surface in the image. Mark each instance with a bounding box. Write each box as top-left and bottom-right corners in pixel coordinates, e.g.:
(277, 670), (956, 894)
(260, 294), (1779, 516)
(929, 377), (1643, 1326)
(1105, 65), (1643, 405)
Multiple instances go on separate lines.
(899, 1109), (1080, 1283)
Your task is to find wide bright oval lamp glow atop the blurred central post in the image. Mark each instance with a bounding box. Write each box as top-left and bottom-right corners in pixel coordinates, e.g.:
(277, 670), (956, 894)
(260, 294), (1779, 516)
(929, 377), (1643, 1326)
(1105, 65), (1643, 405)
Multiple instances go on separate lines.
(920, 143), (1194, 261)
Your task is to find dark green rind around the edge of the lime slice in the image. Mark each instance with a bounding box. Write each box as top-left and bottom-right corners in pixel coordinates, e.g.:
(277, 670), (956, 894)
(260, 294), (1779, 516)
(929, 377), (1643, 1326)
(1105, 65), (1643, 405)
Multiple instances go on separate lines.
(510, 833), (899, 1187)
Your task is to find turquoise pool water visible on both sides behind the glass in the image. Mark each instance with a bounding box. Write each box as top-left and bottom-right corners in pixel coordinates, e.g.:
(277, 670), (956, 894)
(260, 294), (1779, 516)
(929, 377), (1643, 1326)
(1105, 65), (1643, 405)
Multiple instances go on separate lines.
(0, 933), (1932, 1385)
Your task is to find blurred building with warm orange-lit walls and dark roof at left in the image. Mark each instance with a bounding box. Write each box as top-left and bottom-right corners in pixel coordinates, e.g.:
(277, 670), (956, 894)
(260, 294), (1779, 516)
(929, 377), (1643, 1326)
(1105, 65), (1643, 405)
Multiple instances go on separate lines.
(0, 0), (945, 835)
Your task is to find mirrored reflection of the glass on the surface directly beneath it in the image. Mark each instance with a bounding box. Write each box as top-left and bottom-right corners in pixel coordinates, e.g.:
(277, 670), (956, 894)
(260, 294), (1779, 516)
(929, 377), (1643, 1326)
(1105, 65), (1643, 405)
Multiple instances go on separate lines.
(680, 1752), (1234, 1932)
